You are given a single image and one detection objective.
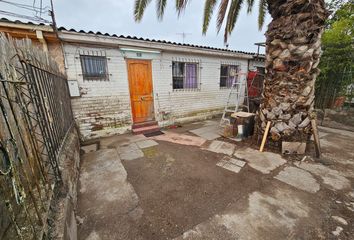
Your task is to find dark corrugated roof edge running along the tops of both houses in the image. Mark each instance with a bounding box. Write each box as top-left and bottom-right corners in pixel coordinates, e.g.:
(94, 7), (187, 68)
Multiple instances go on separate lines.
(0, 18), (265, 60)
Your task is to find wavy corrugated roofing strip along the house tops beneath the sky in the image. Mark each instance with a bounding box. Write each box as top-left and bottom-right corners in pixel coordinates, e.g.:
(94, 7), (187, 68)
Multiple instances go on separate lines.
(0, 18), (264, 58)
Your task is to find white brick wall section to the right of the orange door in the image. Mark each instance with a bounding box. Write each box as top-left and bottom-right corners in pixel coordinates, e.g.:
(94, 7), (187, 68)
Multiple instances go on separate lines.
(153, 52), (247, 123)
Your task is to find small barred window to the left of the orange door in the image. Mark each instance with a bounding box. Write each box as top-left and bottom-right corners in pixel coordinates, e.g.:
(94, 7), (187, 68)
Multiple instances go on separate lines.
(80, 55), (108, 80)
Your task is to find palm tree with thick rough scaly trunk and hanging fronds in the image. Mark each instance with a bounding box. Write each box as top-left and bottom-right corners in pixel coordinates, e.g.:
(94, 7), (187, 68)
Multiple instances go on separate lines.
(134, 0), (328, 141)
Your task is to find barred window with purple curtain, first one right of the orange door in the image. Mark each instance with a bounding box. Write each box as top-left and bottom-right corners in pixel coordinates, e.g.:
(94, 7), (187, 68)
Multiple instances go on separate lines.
(172, 62), (198, 89)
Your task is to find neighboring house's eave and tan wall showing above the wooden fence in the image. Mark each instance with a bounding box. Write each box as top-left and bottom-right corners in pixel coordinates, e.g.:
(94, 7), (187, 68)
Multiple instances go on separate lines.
(0, 18), (65, 73)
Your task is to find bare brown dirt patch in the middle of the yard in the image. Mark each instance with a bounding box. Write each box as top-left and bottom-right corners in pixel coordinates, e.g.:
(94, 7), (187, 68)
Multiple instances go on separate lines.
(123, 142), (265, 239)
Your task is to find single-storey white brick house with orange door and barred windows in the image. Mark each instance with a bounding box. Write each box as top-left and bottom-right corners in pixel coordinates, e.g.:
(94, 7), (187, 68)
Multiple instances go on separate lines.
(0, 18), (264, 140)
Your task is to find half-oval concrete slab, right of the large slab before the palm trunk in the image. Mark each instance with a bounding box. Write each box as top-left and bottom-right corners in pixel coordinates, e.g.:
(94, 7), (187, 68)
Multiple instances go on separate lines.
(274, 166), (320, 193)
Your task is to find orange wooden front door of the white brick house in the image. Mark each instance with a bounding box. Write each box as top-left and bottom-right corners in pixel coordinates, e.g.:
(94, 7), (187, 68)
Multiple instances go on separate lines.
(127, 60), (154, 123)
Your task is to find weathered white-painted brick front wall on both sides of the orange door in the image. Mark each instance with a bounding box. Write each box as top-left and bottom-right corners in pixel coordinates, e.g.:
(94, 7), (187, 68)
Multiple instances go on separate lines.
(64, 41), (258, 139)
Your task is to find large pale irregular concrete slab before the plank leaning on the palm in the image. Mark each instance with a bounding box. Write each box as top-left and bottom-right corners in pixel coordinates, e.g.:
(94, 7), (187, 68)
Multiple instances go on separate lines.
(234, 148), (286, 174)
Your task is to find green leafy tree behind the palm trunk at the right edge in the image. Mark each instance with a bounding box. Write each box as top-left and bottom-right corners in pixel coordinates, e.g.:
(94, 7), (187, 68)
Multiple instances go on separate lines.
(316, 1), (354, 108)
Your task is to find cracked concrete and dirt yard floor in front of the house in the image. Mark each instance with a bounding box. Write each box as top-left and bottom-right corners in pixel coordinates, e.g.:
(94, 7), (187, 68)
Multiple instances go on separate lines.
(77, 121), (354, 240)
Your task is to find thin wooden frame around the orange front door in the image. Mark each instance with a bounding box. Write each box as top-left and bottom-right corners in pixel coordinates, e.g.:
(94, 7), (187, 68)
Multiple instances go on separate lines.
(125, 58), (156, 125)
